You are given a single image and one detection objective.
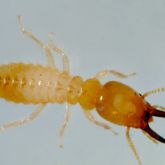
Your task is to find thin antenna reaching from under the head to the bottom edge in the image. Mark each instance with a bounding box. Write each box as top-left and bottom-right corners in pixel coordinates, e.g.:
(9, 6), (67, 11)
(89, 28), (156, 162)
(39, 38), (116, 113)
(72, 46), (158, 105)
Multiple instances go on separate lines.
(126, 127), (141, 165)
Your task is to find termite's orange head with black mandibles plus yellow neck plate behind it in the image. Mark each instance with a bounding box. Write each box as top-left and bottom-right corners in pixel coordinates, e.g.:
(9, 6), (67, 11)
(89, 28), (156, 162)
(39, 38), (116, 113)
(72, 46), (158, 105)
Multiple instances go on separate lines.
(78, 79), (165, 143)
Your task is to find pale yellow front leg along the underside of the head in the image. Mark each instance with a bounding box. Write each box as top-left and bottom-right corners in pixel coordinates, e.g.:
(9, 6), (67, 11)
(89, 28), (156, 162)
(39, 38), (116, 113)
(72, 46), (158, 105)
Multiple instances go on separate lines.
(84, 111), (117, 135)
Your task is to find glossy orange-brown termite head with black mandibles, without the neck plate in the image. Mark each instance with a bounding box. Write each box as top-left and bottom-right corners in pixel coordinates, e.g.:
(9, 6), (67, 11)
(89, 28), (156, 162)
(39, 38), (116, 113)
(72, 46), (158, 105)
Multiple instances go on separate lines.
(96, 81), (165, 142)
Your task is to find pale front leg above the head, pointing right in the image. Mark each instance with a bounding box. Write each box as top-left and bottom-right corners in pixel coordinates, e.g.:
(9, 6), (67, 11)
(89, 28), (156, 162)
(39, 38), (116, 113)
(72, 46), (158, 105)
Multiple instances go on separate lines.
(94, 70), (136, 79)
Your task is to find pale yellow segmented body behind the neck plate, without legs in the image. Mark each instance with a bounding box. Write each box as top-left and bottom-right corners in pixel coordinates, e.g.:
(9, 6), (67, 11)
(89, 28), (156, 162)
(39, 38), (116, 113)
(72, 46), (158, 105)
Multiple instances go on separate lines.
(0, 63), (83, 104)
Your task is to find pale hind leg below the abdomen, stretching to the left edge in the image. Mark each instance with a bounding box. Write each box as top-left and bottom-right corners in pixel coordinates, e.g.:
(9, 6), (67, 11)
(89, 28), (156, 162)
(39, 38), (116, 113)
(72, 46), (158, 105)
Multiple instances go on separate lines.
(0, 104), (46, 131)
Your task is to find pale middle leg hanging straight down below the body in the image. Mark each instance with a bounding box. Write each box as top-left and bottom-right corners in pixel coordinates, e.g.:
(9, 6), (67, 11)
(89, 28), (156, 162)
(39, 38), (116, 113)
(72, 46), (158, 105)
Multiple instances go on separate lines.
(59, 103), (71, 148)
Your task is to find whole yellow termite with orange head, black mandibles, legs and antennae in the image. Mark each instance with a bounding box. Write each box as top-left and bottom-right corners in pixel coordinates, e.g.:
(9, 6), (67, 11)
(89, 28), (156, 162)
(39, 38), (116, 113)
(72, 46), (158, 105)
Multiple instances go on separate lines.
(0, 16), (165, 165)
